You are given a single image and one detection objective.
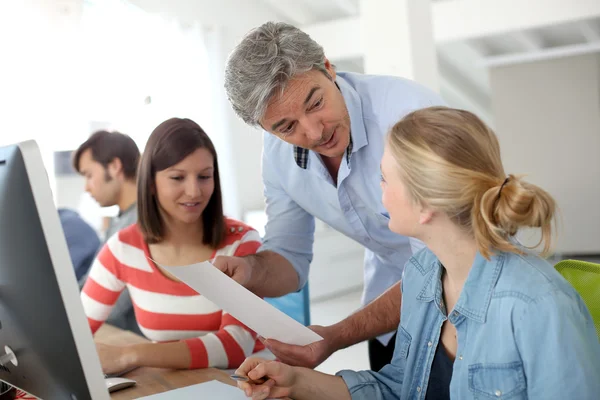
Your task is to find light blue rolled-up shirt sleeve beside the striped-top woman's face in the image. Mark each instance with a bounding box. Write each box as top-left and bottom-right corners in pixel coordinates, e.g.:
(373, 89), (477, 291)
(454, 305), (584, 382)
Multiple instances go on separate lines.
(258, 141), (315, 289)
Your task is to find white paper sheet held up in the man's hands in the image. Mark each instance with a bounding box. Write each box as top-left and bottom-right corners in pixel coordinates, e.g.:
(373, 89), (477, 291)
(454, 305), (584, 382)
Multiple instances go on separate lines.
(156, 261), (323, 346)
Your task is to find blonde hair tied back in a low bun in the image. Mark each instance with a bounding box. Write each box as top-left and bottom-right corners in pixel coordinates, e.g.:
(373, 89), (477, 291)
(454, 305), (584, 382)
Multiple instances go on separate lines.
(388, 107), (556, 259)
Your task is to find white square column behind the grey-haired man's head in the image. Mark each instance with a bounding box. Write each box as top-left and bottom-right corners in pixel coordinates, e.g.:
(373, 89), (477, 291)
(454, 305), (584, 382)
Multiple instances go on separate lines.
(360, 0), (439, 91)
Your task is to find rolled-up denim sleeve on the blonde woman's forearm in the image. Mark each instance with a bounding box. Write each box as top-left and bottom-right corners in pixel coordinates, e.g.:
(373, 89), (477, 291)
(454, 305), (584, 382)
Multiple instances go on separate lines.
(336, 364), (403, 400)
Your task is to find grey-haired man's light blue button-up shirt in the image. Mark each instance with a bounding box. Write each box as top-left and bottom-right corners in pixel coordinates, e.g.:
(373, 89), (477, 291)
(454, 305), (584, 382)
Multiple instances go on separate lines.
(260, 72), (444, 344)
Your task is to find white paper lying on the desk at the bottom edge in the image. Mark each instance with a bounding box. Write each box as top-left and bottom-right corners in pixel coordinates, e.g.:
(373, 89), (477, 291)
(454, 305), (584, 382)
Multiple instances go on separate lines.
(138, 381), (248, 400)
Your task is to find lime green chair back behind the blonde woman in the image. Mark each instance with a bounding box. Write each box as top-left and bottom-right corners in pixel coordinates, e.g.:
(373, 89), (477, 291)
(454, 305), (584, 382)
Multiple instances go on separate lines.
(554, 260), (600, 338)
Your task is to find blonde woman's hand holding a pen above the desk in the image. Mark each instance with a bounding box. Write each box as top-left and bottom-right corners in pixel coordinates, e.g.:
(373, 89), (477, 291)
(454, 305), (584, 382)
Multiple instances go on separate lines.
(235, 358), (296, 400)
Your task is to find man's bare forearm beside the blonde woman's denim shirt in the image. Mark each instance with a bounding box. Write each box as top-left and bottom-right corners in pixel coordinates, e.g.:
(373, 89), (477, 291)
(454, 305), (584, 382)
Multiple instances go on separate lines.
(331, 282), (402, 349)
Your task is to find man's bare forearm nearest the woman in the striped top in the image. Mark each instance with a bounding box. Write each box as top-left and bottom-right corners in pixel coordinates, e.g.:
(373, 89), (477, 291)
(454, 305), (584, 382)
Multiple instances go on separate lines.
(247, 251), (299, 297)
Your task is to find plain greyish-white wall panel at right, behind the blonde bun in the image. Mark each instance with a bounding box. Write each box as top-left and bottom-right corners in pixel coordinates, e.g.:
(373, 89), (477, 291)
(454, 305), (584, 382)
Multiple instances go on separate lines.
(490, 55), (600, 254)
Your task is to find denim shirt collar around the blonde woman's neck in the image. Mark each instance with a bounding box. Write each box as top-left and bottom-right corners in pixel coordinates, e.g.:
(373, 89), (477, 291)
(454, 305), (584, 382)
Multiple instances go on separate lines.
(412, 252), (506, 323)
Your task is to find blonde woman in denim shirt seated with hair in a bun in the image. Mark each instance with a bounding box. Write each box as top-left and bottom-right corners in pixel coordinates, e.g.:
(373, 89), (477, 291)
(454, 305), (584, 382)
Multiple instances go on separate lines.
(238, 107), (600, 400)
